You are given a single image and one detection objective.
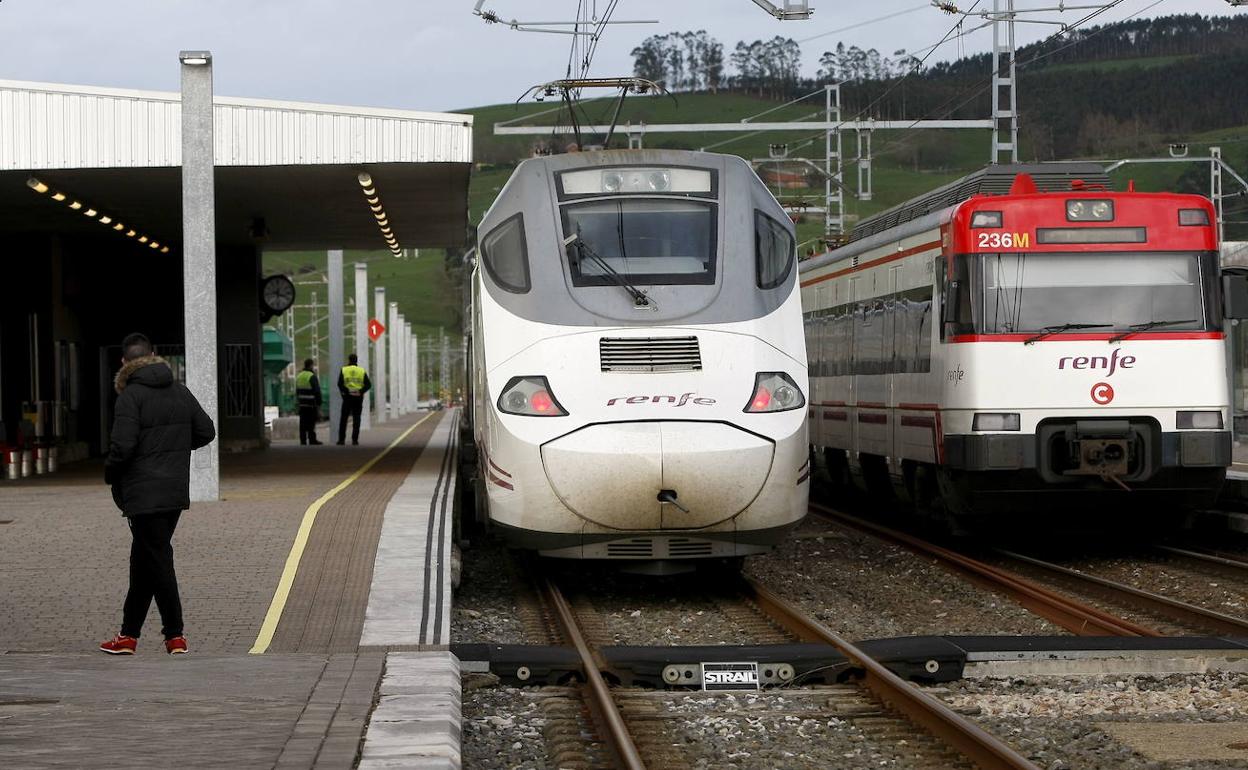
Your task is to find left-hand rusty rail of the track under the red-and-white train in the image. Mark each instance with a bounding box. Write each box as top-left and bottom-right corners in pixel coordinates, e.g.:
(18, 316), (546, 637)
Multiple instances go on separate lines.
(810, 503), (1163, 636)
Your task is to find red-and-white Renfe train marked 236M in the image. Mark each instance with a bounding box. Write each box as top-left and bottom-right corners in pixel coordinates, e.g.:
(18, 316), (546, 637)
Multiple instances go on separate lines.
(800, 163), (1242, 517)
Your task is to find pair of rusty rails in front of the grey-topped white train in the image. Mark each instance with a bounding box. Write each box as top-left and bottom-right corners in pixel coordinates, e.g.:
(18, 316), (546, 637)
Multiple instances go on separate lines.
(535, 559), (1035, 770)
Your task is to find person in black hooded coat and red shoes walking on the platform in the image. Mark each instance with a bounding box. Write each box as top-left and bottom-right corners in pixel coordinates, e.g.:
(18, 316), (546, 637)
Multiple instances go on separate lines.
(100, 334), (216, 654)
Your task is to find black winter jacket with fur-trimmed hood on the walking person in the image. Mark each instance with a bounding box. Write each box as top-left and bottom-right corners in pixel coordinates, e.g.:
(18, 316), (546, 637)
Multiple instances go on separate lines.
(104, 356), (216, 517)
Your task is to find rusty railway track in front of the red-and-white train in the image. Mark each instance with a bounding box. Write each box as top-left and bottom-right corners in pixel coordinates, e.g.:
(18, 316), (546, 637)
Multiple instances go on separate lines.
(811, 504), (1248, 636)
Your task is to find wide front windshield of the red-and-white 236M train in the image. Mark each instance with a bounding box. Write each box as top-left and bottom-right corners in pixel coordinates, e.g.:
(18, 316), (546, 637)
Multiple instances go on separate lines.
(950, 252), (1222, 334)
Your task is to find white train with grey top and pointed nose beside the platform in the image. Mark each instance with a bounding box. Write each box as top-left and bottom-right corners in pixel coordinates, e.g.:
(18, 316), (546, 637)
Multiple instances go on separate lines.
(468, 150), (810, 562)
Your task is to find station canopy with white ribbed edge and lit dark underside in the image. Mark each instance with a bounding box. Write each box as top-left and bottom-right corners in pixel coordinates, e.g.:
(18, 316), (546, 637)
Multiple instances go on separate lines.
(0, 80), (472, 248)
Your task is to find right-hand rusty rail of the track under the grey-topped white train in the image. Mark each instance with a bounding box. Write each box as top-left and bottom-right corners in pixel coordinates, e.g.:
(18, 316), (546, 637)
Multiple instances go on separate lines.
(743, 578), (1038, 770)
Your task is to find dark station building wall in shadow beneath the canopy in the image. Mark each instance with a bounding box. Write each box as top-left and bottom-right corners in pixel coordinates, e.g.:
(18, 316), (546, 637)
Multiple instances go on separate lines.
(0, 235), (263, 462)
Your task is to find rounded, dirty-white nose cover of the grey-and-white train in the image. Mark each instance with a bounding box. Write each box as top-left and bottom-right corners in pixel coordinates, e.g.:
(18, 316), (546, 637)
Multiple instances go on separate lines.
(542, 421), (775, 529)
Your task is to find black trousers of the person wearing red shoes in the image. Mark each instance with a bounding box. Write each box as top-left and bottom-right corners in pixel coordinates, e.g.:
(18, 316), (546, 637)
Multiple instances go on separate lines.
(121, 510), (182, 639)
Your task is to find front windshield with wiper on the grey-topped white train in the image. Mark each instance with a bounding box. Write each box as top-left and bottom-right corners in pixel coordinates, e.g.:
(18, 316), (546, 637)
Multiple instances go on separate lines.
(563, 197), (716, 286)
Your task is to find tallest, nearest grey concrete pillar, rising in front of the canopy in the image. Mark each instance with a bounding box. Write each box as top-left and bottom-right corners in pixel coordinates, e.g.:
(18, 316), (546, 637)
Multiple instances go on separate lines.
(178, 51), (221, 502)
